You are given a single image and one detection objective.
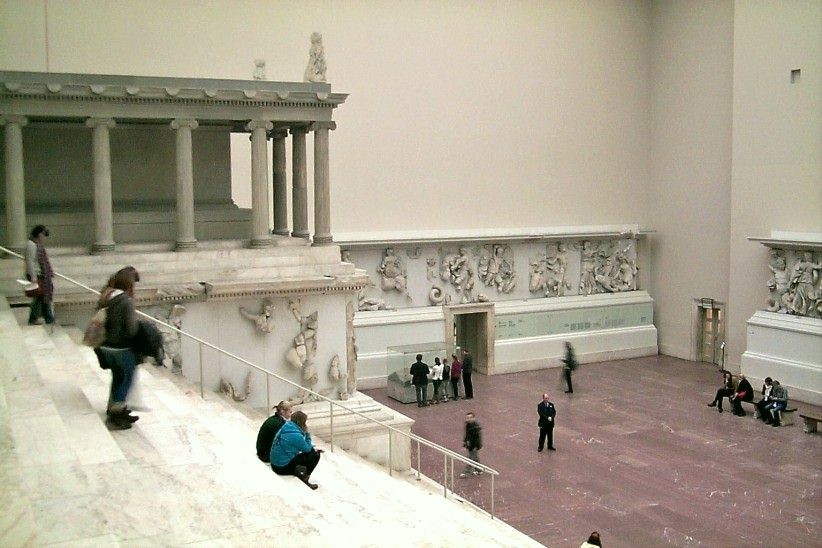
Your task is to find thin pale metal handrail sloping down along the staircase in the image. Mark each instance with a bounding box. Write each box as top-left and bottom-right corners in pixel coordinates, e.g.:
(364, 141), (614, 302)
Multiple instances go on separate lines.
(0, 246), (499, 519)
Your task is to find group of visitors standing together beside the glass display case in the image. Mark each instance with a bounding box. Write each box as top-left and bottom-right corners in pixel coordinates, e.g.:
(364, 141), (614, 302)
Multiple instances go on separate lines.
(409, 350), (474, 407)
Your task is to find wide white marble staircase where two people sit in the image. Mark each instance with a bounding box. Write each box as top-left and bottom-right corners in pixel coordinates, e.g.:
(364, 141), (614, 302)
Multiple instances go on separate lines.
(0, 297), (538, 546)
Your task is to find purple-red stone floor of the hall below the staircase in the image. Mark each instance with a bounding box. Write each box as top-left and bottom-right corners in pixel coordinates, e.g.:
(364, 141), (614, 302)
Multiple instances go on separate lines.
(366, 356), (822, 547)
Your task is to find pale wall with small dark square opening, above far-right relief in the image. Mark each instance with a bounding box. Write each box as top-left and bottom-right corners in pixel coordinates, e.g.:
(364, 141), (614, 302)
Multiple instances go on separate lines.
(728, 0), (822, 363)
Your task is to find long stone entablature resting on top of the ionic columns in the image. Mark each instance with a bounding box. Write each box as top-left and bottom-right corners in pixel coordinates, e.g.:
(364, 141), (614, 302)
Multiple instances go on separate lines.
(0, 71), (348, 122)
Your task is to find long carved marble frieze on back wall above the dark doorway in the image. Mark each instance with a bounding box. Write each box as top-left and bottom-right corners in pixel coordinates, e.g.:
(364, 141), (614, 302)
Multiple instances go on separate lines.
(342, 232), (639, 311)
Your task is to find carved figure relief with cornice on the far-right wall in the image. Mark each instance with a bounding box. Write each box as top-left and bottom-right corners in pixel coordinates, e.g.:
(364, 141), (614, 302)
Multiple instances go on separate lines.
(748, 231), (822, 318)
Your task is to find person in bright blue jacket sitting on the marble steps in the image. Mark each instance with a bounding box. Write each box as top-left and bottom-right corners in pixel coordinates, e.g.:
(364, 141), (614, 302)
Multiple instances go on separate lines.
(269, 411), (323, 489)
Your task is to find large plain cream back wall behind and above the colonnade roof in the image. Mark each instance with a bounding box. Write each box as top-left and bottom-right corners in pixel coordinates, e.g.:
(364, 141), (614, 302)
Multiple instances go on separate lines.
(0, 0), (649, 230)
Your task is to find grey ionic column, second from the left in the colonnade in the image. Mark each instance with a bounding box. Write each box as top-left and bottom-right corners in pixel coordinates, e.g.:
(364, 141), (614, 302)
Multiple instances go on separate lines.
(86, 118), (115, 253)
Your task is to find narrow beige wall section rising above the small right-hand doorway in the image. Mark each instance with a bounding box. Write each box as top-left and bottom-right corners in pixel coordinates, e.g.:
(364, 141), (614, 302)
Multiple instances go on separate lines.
(650, 0), (744, 359)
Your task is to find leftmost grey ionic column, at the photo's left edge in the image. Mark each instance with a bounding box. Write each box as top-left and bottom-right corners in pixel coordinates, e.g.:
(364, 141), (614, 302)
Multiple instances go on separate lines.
(0, 115), (28, 253)
